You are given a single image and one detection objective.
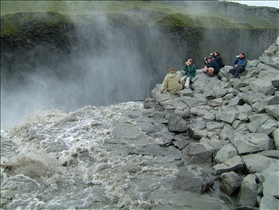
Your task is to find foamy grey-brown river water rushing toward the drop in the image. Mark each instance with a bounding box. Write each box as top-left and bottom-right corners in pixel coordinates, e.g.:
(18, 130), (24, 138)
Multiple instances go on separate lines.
(1, 102), (228, 209)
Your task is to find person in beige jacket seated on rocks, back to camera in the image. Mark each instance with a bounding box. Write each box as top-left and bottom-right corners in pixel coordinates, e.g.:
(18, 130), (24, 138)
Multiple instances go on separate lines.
(159, 68), (182, 94)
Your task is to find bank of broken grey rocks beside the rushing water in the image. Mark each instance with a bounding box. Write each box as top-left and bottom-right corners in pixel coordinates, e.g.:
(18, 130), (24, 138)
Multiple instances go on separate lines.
(130, 37), (279, 209)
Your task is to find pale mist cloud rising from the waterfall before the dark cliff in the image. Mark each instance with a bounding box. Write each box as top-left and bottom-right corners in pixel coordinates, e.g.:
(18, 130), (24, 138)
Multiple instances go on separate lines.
(1, 16), (186, 129)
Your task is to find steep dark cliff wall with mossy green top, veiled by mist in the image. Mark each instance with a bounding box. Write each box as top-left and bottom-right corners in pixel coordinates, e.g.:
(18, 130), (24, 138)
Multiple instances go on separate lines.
(1, 1), (279, 119)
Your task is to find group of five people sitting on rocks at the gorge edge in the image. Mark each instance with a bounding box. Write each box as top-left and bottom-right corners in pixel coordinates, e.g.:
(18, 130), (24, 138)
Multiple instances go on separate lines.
(159, 50), (247, 94)
